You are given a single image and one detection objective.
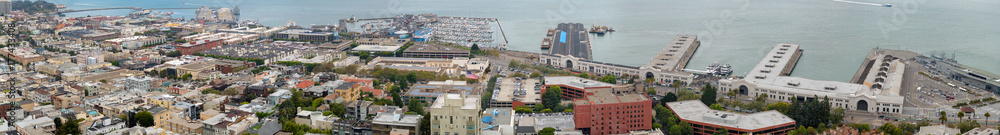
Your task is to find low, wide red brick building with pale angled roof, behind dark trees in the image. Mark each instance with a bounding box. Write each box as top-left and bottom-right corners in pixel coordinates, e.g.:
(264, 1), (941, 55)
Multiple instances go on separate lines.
(666, 100), (795, 135)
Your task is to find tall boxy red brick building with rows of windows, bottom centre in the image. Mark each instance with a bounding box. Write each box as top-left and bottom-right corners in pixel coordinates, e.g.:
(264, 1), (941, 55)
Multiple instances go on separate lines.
(573, 86), (653, 135)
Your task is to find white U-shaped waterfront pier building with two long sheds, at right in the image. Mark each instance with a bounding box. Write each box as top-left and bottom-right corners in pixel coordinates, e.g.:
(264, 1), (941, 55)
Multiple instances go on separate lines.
(718, 43), (905, 114)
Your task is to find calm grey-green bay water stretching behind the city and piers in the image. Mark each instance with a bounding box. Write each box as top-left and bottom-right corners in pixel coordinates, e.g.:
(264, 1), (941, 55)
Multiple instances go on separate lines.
(52, 0), (1000, 81)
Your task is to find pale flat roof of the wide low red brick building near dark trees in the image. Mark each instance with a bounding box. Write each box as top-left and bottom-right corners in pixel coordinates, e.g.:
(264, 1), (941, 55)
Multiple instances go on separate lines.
(667, 100), (795, 130)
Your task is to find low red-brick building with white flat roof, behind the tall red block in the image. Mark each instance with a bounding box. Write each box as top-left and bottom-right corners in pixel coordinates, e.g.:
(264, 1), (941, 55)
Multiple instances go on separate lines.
(542, 76), (615, 99)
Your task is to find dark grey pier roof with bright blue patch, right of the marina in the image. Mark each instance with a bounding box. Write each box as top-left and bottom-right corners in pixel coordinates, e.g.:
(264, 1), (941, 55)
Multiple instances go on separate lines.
(549, 23), (593, 60)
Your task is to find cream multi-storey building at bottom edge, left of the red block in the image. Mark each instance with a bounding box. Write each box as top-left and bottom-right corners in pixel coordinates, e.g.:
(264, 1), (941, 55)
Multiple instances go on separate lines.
(430, 93), (482, 135)
